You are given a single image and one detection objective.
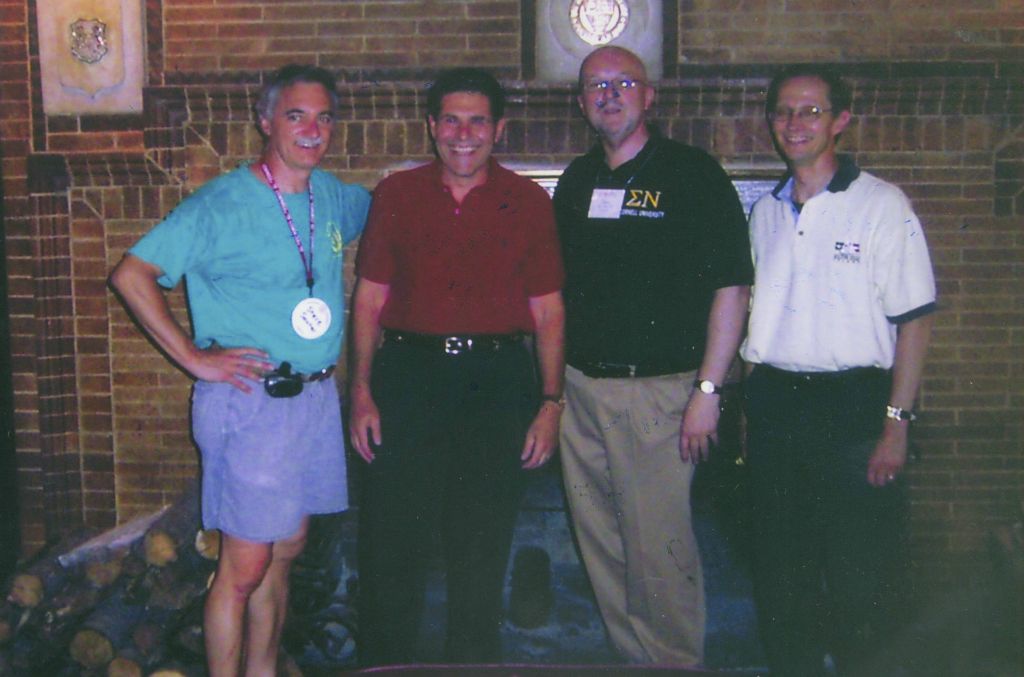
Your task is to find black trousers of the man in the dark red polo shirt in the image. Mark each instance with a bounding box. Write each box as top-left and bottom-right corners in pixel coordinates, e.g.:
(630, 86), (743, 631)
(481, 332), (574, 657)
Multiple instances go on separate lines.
(358, 343), (539, 666)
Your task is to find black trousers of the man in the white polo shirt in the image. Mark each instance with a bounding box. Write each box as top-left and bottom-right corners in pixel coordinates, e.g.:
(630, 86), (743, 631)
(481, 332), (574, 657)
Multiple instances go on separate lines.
(745, 366), (905, 677)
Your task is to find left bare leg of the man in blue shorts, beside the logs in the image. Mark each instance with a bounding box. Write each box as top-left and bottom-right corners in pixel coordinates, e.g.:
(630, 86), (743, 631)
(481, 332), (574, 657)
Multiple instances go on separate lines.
(203, 534), (272, 677)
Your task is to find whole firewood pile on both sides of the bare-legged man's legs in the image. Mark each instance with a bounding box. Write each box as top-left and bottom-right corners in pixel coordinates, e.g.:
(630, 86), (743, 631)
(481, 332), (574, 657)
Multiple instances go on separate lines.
(0, 486), (355, 677)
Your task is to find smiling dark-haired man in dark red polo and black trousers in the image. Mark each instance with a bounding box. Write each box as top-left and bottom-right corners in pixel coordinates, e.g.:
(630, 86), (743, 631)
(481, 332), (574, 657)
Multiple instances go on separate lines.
(349, 69), (564, 665)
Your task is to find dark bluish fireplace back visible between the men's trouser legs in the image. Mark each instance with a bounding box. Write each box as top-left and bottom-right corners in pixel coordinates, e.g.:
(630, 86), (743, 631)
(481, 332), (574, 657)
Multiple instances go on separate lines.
(297, 456), (764, 675)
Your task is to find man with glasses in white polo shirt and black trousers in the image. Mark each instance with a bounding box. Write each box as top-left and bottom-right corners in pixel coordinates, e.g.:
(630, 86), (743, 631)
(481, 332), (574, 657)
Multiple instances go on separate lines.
(740, 66), (935, 677)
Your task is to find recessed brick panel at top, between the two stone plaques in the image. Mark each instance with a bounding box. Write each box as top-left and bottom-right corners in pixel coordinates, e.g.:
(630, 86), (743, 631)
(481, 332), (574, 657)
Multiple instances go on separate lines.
(163, 0), (520, 82)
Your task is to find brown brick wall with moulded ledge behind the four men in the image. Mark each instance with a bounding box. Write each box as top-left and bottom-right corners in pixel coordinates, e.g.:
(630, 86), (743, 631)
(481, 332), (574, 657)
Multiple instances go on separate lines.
(0, 0), (1024, 580)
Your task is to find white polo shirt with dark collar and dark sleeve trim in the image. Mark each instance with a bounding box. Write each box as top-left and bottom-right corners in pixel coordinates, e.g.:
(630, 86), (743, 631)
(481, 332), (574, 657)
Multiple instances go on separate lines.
(740, 158), (935, 372)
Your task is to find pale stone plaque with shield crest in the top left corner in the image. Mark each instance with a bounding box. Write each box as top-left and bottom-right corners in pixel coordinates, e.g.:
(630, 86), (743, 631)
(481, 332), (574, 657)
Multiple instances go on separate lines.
(37, 0), (142, 115)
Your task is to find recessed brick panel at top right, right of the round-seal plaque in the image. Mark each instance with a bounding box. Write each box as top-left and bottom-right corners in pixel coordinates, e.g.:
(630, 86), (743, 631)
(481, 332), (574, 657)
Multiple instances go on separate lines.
(679, 0), (1024, 67)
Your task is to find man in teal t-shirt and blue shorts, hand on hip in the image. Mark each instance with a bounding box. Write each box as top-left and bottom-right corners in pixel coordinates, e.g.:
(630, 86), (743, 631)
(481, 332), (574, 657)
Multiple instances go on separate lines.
(111, 66), (370, 677)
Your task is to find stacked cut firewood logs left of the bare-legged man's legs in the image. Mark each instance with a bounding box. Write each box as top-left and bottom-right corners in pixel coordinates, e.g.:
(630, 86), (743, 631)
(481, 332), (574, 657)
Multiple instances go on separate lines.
(0, 488), (219, 675)
